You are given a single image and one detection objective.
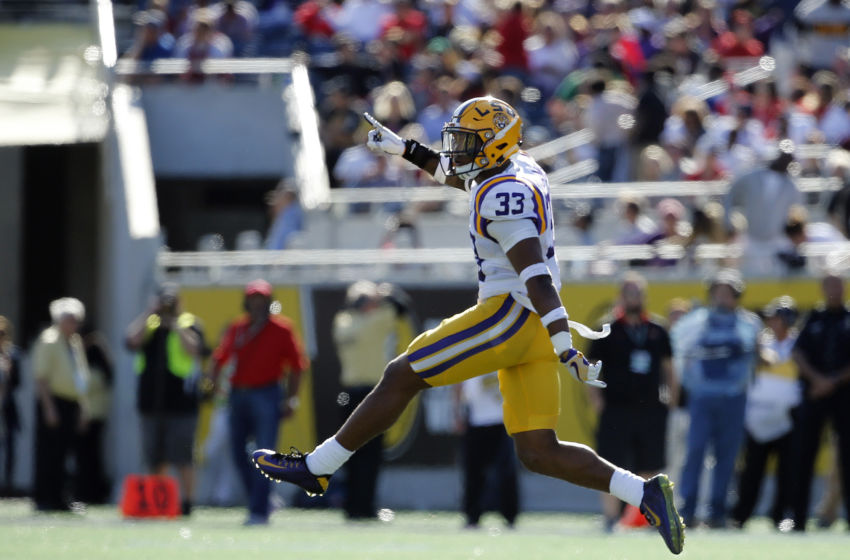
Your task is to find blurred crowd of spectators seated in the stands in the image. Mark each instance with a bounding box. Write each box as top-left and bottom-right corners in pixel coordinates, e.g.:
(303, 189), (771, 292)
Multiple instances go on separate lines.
(124, 0), (850, 273)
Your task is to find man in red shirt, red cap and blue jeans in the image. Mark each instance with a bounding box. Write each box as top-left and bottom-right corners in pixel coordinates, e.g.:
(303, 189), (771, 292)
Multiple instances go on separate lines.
(211, 280), (309, 525)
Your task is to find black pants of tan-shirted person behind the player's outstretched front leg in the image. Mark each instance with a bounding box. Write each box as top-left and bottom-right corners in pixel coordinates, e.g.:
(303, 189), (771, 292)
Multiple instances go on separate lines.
(343, 387), (384, 519)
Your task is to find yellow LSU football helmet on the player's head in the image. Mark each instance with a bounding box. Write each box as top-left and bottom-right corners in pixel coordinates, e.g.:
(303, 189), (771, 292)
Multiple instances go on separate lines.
(441, 97), (522, 179)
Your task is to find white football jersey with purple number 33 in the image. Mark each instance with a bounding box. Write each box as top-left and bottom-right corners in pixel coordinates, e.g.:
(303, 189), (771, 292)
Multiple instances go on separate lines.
(469, 152), (561, 311)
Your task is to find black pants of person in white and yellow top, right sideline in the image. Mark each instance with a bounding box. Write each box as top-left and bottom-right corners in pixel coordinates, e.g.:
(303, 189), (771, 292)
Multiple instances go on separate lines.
(732, 433), (794, 525)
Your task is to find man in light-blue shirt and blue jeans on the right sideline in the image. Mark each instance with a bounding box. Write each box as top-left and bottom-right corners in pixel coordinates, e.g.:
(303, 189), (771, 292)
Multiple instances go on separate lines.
(671, 268), (762, 528)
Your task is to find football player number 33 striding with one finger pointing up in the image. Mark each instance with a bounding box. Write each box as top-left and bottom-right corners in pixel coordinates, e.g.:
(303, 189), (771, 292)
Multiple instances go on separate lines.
(253, 97), (685, 554)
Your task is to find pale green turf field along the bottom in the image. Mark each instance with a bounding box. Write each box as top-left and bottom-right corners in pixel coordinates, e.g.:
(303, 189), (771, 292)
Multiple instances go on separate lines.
(0, 500), (850, 560)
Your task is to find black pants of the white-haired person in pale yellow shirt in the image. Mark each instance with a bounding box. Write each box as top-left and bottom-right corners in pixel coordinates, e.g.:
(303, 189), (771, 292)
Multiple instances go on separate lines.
(33, 397), (80, 511)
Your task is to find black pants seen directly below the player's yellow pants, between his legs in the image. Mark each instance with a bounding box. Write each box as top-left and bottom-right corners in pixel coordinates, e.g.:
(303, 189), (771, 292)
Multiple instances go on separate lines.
(463, 424), (519, 525)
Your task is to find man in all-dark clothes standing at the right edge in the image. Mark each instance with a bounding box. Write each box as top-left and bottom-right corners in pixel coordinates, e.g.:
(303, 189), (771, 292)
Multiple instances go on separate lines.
(792, 274), (850, 531)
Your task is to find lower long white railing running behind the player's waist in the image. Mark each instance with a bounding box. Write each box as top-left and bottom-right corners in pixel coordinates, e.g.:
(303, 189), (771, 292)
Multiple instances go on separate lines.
(157, 242), (850, 284)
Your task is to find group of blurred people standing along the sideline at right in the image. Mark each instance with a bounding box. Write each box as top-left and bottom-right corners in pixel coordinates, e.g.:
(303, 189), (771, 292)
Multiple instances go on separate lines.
(588, 269), (850, 532)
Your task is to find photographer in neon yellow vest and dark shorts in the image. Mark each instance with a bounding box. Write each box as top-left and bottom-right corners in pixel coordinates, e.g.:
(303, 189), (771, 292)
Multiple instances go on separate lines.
(125, 283), (204, 515)
